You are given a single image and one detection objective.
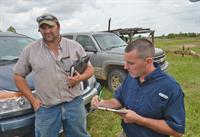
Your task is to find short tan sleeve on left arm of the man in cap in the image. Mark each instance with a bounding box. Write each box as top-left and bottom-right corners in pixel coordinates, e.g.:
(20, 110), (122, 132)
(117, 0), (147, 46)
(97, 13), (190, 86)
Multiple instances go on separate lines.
(13, 47), (32, 77)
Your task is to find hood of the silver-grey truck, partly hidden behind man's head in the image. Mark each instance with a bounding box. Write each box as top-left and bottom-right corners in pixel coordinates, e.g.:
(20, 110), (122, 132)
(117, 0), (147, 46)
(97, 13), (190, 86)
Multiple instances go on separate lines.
(105, 46), (164, 56)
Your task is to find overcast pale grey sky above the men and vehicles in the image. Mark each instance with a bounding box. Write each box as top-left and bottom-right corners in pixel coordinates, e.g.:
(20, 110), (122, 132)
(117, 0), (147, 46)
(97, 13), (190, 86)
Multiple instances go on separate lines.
(0, 0), (200, 38)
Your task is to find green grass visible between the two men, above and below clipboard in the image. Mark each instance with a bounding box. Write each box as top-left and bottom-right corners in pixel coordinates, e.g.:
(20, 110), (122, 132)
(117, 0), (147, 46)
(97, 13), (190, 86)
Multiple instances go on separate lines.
(88, 88), (121, 137)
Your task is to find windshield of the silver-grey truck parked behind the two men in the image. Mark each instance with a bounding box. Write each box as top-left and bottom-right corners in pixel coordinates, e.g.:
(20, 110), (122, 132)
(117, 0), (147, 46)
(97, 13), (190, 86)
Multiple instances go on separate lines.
(93, 33), (127, 50)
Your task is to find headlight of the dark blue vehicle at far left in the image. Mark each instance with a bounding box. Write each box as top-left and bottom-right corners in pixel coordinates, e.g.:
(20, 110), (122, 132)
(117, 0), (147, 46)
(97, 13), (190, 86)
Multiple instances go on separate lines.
(0, 90), (32, 119)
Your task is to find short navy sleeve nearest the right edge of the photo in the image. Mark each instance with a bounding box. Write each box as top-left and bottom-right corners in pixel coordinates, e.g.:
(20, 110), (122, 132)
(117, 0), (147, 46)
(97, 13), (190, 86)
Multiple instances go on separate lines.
(165, 88), (185, 133)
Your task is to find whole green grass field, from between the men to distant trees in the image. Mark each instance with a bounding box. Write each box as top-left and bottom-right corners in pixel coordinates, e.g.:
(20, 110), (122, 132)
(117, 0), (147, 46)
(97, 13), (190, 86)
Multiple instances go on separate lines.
(88, 38), (200, 137)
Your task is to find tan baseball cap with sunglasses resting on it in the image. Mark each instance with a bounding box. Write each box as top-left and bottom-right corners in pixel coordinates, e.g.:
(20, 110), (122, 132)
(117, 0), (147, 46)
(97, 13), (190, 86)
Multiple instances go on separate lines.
(36, 14), (58, 26)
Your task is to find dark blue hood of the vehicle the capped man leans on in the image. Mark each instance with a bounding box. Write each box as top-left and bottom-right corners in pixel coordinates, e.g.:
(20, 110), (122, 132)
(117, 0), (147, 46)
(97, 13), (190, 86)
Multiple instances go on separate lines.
(0, 64), (34, 92)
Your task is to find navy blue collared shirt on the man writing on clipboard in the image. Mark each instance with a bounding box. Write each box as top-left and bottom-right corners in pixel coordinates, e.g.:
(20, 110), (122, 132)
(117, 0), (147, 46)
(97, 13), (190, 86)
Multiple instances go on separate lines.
(114, 67), (185, 137)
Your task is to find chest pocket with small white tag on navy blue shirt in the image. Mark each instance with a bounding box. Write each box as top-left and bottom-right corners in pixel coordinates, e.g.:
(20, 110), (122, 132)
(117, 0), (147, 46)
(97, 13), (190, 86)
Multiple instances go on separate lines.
(140, 91), (169, 118)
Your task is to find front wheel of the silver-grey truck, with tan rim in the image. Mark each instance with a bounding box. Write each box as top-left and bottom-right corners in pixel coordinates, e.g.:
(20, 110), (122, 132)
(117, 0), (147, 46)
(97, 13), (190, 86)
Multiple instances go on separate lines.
(107, 69), (127, 91)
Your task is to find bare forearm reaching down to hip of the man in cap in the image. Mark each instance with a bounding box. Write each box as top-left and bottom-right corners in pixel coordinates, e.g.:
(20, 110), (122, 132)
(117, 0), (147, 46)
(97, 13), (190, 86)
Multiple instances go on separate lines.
(14, 74), (35, 103)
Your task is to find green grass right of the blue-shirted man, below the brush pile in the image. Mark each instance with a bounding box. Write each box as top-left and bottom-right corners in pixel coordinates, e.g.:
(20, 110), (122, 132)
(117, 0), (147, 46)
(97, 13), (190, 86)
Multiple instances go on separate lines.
(167, 54), (200, 137)
